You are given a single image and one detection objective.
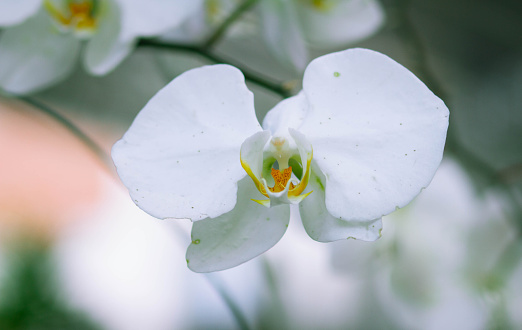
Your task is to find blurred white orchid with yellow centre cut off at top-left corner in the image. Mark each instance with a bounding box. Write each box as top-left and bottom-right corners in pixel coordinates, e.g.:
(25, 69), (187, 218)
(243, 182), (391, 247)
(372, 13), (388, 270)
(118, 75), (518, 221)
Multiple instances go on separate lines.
(0, 0), (202, 94)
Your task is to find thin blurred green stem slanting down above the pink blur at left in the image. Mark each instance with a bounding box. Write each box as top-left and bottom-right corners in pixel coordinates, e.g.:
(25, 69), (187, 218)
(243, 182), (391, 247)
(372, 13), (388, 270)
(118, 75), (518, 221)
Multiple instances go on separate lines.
(18, 96), (113, 172)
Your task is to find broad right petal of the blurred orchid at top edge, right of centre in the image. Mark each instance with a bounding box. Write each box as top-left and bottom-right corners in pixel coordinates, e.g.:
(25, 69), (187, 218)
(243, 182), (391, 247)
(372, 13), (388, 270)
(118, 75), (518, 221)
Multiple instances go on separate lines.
(296, 0), (384, 47)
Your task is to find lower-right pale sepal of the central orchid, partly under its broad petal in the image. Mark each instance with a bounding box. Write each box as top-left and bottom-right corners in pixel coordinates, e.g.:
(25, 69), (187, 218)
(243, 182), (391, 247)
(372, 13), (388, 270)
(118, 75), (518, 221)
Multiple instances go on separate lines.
(299, 171), (382, 242)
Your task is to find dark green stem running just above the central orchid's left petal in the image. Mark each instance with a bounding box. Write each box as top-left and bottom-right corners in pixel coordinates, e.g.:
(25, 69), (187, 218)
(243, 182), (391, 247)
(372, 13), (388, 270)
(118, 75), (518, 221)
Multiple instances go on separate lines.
(138, 39), (293, 98)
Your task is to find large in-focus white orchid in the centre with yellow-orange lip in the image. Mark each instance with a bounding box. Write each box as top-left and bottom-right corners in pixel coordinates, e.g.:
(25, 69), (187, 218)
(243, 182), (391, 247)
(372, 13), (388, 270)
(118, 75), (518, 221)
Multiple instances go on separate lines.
(112, 49), (449, 272)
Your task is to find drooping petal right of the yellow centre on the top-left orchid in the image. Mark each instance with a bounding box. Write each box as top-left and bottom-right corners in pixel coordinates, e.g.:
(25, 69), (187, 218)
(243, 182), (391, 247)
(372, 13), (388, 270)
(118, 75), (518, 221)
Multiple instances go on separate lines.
(83, 1), (125, 75)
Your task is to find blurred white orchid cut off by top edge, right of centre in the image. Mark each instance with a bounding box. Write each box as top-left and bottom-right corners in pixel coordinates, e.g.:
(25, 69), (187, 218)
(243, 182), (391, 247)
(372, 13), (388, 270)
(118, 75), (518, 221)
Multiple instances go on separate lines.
(260, 0), (385, 72)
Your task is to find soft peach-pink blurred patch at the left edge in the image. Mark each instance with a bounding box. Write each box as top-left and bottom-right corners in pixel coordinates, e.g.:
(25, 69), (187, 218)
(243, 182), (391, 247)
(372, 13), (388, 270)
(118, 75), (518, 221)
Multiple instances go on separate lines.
(0, 99), (103, 240)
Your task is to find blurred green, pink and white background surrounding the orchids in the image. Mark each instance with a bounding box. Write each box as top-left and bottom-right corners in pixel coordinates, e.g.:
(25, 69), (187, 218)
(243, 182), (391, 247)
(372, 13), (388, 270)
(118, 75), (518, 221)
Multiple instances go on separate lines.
(0, 0), (522, 329)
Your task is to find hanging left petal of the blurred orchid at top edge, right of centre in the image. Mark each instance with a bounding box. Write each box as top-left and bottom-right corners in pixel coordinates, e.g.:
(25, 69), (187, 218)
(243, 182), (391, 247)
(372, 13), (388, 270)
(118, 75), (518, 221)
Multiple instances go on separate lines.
(259, 0), (308, 72)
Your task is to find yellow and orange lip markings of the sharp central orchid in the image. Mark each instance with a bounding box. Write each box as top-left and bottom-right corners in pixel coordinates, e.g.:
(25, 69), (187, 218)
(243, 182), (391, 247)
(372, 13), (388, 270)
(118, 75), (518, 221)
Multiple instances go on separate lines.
(240, 131), (313, 206)
